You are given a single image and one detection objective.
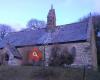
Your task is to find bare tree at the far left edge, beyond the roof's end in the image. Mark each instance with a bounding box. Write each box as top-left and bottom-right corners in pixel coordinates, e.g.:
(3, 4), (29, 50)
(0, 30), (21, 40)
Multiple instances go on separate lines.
(0, 24), (14, 40)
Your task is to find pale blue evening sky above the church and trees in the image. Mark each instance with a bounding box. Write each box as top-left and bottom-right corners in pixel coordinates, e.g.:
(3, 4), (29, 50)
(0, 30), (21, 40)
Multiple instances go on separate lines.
(0, 0), (100, 30)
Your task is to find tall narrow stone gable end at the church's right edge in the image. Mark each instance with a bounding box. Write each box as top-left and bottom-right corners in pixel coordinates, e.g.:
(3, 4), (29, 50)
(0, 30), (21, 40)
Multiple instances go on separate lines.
(87, 16), (98, 70)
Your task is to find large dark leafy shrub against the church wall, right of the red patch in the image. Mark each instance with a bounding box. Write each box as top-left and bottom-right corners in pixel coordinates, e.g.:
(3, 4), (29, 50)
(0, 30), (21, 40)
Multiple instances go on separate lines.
(49, 46), (74, 66)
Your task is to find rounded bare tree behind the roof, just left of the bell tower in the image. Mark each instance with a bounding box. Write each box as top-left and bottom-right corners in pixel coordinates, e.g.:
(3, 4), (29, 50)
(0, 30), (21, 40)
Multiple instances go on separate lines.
(27, 19), (46, 29)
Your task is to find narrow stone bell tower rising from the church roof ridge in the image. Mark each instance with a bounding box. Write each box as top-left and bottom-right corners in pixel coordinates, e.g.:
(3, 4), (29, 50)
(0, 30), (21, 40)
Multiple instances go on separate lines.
(47, 5), (56, 30)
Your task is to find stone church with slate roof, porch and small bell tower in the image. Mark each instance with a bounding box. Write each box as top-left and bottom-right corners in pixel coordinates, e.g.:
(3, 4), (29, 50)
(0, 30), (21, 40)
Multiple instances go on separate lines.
(0, 7), (97, 69)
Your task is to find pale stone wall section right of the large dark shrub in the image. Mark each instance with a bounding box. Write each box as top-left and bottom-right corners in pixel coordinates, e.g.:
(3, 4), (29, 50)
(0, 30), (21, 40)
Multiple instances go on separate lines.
(68, 42), (92, 65)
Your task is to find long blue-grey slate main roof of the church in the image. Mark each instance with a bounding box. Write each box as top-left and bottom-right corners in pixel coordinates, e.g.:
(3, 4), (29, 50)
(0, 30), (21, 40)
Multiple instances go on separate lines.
(0, 22), (88, 48)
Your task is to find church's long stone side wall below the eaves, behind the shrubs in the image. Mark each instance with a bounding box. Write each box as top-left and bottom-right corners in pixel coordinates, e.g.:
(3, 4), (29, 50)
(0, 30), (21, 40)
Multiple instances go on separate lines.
(0, 42), (93, 66)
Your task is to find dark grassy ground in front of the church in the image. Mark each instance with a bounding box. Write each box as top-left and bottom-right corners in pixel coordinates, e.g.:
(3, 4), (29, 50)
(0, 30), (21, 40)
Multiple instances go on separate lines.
(0, 66), (100, 80)
